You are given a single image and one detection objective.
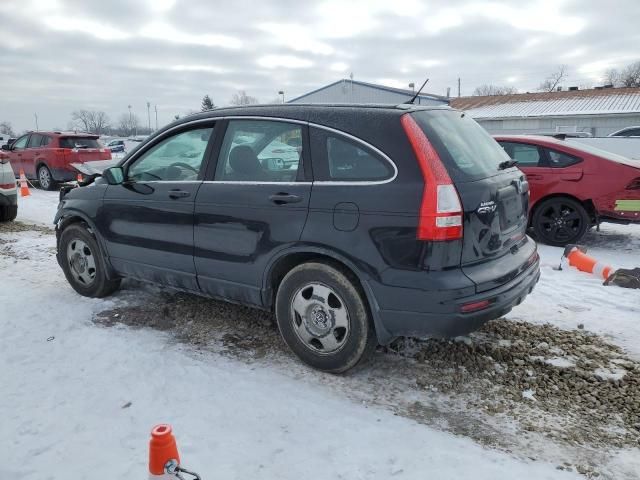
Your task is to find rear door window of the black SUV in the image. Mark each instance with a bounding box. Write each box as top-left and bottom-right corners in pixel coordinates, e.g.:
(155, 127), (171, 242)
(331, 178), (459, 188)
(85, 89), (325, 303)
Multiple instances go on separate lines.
(215, 120), (302, 182)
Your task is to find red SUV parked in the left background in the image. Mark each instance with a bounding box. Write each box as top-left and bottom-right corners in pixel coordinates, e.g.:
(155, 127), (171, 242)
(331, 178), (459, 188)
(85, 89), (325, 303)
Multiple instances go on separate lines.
(0, 132), (111, 190)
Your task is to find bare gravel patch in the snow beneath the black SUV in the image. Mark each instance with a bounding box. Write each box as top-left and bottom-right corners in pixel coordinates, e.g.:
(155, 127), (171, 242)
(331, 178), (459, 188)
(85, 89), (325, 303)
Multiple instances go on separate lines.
(95, 293), (640, 466)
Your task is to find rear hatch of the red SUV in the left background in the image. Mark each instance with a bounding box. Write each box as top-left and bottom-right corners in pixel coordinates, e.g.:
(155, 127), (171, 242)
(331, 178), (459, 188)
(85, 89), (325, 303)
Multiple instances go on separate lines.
(60, 135), (115, 175)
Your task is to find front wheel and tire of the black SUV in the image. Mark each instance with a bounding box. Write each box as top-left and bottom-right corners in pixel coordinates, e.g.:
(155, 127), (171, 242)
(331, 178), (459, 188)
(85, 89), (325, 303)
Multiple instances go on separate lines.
(58, 223), (120, 298)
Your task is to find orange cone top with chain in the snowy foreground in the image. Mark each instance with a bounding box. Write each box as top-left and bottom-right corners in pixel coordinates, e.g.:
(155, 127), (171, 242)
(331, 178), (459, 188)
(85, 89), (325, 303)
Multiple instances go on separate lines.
(149, 423), (200, 480)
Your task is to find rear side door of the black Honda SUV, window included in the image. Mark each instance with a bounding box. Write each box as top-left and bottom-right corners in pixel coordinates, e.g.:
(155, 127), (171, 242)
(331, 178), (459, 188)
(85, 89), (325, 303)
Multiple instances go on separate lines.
(194, 119), (311, 305)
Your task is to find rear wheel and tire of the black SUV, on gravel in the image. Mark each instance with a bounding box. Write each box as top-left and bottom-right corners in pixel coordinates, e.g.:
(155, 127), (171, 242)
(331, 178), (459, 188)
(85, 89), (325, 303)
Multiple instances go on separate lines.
(276, 262), (378, 373)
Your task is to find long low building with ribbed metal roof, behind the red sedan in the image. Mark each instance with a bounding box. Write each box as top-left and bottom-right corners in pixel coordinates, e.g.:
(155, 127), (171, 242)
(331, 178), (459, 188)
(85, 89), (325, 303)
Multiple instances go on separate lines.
(451, 87), (640, 137)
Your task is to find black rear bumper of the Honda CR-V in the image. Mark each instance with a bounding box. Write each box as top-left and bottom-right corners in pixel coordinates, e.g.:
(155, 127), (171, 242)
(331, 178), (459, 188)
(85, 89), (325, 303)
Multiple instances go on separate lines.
(373, 252), (540, 337)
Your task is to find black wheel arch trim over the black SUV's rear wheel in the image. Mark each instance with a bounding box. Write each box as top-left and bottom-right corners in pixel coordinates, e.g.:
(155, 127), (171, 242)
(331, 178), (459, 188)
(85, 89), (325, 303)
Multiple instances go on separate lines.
(262, 247), (394, 345)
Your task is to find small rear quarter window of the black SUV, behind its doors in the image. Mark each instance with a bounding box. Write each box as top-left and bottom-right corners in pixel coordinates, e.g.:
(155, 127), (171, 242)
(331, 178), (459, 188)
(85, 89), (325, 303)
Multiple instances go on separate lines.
(327, 136), (393, 181)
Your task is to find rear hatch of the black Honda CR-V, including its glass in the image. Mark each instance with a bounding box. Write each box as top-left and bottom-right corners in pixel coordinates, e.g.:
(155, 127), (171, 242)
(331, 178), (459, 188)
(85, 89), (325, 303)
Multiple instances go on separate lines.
(412, 110), (536, 292)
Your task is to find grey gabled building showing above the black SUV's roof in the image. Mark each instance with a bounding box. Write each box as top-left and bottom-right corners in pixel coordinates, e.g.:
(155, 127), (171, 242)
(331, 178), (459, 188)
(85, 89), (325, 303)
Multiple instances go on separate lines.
(287, 78), (449, 105)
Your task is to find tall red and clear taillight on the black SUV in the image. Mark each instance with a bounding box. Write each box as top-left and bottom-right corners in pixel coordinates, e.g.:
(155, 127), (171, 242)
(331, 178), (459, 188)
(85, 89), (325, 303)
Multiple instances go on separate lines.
(400, 114), (463, 241)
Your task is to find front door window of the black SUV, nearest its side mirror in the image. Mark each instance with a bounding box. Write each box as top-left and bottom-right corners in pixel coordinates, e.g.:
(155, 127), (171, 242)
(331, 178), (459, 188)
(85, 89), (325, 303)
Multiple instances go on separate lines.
(127, 128), (213, 182)
